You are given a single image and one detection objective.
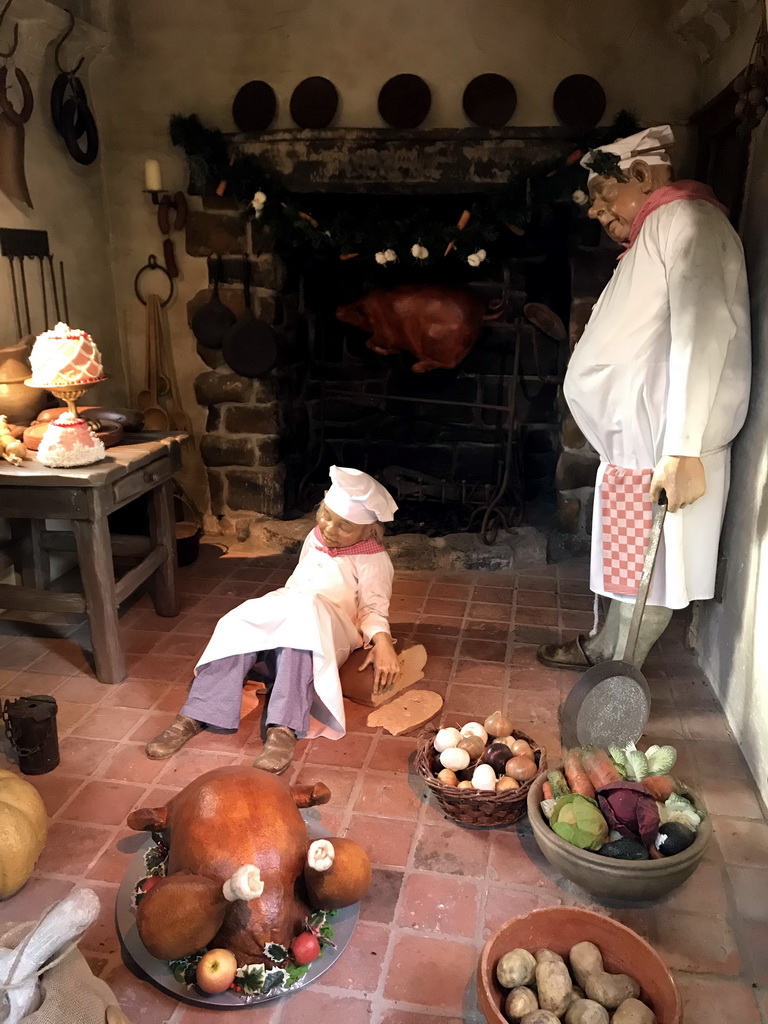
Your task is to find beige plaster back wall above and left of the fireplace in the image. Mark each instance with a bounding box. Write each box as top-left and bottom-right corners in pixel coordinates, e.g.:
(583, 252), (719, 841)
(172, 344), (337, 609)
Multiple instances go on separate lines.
(95, 0), (698, 507)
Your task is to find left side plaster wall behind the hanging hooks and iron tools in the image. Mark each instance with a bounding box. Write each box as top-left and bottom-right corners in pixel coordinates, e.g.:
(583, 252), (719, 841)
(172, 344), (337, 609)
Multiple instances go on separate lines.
(0, 0), (125, 412)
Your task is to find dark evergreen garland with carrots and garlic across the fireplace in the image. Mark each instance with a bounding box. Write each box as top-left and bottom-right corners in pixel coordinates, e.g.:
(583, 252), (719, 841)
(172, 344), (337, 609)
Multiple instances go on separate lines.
(170, 111), (639, 266)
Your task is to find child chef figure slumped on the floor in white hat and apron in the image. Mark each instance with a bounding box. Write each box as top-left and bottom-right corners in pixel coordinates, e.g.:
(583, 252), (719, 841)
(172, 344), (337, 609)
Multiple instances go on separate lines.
(145, 466), (399, 774)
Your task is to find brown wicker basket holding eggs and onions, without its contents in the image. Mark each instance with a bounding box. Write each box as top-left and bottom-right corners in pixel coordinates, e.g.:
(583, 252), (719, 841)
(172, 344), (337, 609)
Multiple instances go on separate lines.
(415, 727), (547, 828)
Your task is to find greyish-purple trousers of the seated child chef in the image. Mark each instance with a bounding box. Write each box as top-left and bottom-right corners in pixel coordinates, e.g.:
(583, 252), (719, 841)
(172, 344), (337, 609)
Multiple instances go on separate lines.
(181, 647), (314, 736)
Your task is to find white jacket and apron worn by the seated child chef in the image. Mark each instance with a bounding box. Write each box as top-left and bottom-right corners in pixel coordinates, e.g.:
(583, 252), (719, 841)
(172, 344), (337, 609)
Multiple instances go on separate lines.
(197, 530), (394, 739)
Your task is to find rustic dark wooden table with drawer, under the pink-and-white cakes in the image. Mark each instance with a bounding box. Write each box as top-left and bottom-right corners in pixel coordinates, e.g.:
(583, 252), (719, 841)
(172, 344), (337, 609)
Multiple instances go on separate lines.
(0, 432), (187, 683)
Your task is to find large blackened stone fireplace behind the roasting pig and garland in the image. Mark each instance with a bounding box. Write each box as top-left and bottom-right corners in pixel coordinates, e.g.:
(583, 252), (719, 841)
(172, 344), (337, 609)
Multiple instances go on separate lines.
(187, 129), (601, 542)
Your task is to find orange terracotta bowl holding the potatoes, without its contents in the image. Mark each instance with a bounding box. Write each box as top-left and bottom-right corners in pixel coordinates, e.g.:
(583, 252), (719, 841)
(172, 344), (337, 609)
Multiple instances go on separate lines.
(477, 906), (683, 1024)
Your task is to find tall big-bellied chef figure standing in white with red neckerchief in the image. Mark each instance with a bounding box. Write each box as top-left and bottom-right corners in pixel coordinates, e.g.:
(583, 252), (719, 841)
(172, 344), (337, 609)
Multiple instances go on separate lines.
(538, 126), (751, 669)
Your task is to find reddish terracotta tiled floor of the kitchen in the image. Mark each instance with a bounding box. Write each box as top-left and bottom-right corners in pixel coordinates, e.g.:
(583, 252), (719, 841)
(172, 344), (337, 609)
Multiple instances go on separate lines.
(0, 545), (768, 1024)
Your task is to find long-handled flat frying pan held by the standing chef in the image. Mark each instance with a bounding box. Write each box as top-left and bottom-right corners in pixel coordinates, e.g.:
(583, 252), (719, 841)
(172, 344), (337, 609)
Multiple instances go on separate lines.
(560, 490), (667, 749)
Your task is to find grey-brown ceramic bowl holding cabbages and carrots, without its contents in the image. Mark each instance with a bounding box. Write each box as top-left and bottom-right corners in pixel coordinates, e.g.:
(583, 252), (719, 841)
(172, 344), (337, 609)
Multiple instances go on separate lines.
(528, 775), (712, 902)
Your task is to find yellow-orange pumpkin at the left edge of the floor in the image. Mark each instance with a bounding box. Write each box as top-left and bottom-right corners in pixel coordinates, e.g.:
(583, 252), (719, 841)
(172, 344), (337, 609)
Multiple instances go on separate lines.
(0, 770), (48, 899)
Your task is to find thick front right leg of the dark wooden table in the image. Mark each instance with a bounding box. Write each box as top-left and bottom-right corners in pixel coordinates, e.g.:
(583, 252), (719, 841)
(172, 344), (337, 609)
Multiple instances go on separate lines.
(72, 515), (127, 683)
